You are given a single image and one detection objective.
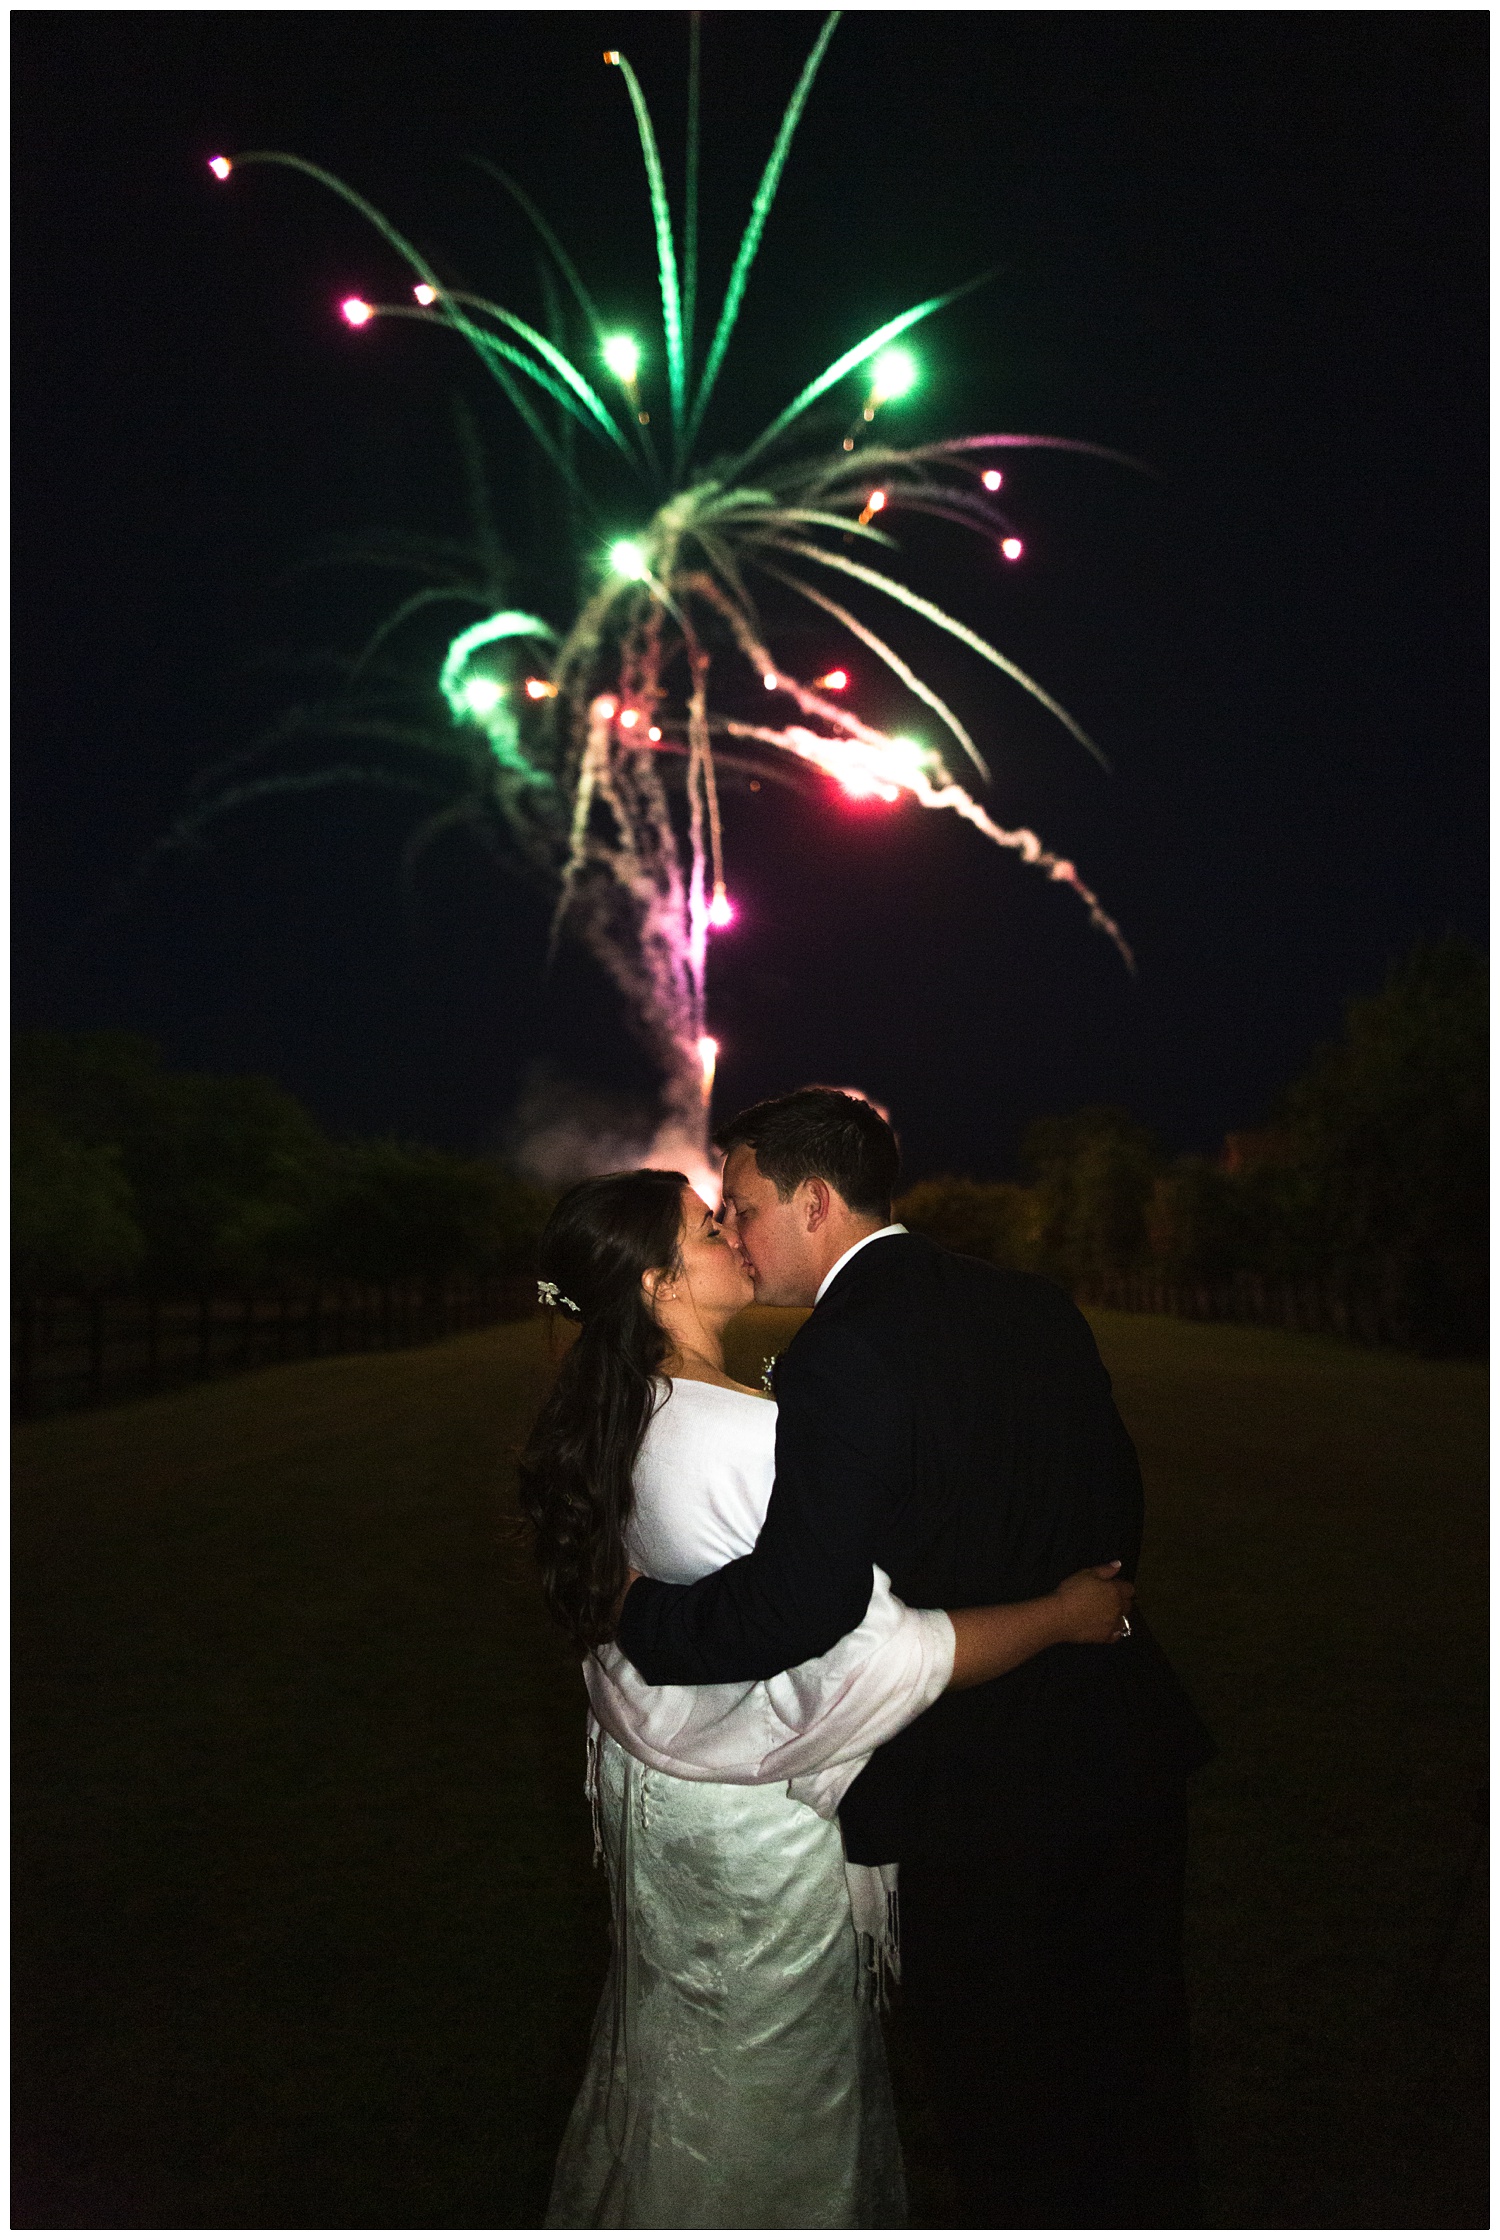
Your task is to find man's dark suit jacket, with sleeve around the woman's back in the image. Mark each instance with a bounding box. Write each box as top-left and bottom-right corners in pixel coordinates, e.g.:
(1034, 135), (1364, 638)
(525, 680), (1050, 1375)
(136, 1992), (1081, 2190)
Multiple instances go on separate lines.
(618, 1236), (1211, 1864)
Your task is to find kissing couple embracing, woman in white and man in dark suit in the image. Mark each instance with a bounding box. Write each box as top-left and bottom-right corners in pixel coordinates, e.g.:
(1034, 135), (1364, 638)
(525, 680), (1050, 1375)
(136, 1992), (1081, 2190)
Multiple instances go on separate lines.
(522, 1089), (1211, 2229)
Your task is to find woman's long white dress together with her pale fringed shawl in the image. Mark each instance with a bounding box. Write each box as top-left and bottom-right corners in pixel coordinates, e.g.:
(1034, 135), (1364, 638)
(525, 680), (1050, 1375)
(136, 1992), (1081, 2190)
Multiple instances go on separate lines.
(546, 1382), (954, 2231)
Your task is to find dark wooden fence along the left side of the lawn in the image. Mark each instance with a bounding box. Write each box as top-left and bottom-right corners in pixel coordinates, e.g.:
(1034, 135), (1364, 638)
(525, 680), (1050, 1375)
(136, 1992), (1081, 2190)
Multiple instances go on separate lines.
(11, 1277), (535, 1418)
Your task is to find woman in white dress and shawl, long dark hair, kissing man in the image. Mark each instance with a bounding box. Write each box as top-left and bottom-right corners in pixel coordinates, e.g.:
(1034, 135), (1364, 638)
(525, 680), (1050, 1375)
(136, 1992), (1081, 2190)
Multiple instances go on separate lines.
(522, 1169), (1133, 2231)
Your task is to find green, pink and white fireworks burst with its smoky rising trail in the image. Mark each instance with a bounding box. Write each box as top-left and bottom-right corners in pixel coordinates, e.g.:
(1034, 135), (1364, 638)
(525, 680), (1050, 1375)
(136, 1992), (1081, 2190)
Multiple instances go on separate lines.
(199, 16), (1128, 1149)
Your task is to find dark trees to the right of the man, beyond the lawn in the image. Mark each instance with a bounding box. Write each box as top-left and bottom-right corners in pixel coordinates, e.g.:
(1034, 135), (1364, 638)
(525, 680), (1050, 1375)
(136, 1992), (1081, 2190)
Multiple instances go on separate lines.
(900, 939), (1489, 1353)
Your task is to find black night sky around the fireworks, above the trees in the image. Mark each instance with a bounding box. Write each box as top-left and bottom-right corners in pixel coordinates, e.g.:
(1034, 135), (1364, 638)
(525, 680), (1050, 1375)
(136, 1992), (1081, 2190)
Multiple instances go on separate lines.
(13, 11), (1487, 1174)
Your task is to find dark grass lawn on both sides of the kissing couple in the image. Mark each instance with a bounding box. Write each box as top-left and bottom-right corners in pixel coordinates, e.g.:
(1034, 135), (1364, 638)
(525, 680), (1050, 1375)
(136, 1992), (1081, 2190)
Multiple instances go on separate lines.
(13, 1315), (1487, 2229)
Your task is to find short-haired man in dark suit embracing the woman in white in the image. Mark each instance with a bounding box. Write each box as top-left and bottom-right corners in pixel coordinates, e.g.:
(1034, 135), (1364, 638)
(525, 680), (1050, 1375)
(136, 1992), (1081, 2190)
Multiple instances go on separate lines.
(618, 1089), (1211, 2229)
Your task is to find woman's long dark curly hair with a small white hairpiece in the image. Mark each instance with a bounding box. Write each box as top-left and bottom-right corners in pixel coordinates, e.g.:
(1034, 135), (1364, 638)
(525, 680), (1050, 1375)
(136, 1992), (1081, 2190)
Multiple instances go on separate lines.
(519, 1167), (687, 1651)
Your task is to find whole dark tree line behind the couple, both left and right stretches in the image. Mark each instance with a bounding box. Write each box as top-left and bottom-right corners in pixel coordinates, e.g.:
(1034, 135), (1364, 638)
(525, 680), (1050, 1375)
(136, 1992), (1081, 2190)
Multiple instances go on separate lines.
(11, 939), (1489, 1353)
